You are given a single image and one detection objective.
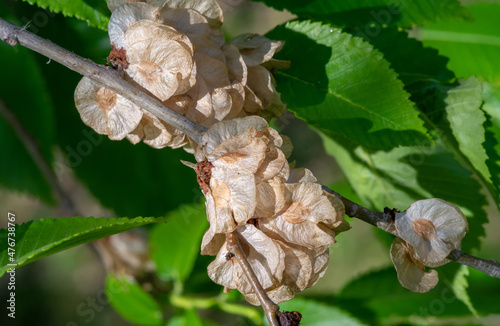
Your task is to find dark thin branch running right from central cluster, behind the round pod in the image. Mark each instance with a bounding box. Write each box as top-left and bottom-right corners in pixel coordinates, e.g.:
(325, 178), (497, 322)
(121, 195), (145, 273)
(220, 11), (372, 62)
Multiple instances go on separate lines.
(323, 186), (500, 278)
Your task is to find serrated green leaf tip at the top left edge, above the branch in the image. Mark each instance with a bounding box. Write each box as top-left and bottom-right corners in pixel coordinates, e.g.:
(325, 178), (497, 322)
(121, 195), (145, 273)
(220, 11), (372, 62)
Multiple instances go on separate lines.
(23, 0), (111, 30)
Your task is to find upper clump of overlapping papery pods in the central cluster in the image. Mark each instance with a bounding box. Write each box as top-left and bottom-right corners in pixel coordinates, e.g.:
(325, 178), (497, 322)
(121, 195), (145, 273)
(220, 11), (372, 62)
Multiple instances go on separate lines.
(195, 117), (289, 254)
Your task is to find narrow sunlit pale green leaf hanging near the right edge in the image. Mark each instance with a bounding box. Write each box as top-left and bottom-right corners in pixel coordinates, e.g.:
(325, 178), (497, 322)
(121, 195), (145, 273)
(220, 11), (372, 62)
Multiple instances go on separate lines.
(445, 77), (491, 183)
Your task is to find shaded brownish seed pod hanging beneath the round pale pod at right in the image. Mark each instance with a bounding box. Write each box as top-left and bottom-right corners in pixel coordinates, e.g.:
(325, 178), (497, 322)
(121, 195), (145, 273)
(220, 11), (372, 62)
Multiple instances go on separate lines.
(391, 238), (439, 293)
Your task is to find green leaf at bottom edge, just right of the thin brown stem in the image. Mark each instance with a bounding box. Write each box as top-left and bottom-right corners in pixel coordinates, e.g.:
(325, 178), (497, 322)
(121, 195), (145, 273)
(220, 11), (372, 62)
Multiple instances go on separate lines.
(280, 298), (366, 326)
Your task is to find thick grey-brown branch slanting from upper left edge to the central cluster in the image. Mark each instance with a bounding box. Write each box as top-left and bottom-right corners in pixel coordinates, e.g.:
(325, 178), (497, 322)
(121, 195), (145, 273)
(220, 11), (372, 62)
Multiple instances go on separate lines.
(0, 18), (206, 143)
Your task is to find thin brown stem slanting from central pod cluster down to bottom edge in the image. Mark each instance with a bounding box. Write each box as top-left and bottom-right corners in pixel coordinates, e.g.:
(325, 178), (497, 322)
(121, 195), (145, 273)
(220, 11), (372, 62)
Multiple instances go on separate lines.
(226, 232), (280, 326)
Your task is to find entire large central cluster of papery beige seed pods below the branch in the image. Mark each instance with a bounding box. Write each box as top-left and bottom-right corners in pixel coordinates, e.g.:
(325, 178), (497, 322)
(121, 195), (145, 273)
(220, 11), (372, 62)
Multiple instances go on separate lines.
(195, 117), (348, 305)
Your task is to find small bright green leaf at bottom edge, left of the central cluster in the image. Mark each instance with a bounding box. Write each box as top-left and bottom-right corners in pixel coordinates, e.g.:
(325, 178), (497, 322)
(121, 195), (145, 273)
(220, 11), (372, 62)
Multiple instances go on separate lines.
(106, 274), (163, 326)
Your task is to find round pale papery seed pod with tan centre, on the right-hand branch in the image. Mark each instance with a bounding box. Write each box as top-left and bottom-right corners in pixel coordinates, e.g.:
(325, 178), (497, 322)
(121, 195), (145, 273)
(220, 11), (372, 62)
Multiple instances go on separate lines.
(395, 198), (468, 267)
